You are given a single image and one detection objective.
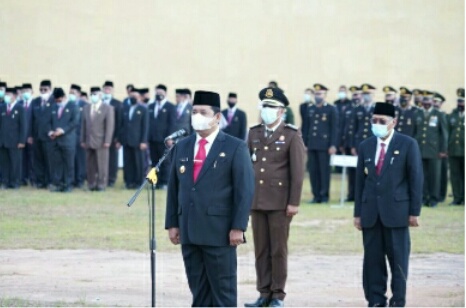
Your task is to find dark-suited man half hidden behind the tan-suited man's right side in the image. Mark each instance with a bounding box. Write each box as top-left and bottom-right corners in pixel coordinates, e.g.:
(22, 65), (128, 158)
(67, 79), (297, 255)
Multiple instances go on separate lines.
(102, 81), (123, 187)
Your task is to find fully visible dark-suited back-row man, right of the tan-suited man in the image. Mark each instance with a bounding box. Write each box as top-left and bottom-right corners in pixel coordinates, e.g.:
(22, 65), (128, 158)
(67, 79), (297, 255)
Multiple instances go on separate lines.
(115, 88), (149, 189)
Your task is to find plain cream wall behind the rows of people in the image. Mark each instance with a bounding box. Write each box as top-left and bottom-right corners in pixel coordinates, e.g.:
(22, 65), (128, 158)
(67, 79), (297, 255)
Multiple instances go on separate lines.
(0, 0), (465, 124)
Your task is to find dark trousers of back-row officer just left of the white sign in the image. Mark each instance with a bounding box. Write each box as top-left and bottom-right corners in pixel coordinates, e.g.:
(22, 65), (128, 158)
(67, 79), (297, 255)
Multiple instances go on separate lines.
(308, 150), (330, 201)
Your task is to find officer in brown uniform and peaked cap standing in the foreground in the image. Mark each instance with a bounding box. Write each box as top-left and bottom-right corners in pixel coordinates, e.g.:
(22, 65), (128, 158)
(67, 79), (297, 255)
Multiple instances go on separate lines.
(245, 87), (308, 307)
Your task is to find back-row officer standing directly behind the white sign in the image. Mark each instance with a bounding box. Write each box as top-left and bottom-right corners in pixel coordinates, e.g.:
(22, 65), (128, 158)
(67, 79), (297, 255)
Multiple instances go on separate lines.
(339, 86), (362, 202)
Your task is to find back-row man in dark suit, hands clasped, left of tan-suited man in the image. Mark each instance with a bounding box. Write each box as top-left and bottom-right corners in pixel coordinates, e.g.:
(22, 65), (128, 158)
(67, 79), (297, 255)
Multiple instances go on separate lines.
(48, 88), (80, 192)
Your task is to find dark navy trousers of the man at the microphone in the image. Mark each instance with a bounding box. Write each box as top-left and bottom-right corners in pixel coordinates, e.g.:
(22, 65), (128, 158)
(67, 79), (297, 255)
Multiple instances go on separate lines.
(181, 244), (237, 307)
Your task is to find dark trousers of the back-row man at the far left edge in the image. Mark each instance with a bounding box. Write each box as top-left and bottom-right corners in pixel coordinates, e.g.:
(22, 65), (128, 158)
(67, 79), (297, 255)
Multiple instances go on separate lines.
(0, 146), (23, 188)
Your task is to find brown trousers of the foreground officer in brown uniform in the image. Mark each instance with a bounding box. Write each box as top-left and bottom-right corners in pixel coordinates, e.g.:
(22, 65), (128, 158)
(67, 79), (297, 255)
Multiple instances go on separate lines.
(251, 210), (292, 300)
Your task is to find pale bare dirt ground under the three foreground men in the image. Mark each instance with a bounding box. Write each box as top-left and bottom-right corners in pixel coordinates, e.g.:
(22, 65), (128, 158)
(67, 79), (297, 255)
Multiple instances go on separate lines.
(0, 250), (465, 306)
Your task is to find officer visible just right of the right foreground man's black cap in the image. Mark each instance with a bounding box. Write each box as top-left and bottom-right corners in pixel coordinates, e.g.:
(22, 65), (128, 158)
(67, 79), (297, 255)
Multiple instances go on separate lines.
(395, 87), (418, 138)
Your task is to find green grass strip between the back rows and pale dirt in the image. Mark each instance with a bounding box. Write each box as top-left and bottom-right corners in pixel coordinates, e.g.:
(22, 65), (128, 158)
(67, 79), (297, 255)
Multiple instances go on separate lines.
(0, 174), (464, 254)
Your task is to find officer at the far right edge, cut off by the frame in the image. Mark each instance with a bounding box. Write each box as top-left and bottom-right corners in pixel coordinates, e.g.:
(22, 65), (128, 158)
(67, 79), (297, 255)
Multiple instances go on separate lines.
(448, 88), (464, 205)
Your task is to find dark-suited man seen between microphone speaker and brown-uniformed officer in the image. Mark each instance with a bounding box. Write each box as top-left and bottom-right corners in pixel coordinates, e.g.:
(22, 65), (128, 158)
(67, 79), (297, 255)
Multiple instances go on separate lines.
(222, 93), (247, 140)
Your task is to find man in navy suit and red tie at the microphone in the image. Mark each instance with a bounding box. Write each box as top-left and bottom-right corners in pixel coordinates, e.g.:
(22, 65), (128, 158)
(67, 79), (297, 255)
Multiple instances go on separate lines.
(165, 91), (254, 307)
